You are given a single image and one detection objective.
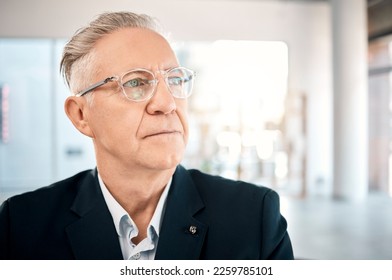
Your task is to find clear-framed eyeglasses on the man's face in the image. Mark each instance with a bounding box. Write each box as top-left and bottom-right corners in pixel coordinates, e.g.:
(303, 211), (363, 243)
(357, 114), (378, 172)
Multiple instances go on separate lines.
(76, 67), (195, 102)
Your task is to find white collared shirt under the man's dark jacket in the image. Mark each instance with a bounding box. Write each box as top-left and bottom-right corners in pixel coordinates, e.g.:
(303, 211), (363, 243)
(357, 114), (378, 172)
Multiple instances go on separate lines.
(98, 173), (172, 260)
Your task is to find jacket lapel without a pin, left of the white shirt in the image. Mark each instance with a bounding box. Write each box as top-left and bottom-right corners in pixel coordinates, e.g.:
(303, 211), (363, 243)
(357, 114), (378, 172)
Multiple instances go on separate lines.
(66, 170), (122, 260)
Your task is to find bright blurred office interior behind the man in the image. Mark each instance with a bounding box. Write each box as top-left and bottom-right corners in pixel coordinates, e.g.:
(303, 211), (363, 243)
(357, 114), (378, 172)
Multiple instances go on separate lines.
(0, 0), (392, 259)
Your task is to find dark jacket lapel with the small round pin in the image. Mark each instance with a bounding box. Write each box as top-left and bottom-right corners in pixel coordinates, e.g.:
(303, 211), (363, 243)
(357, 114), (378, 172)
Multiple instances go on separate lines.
(155, 166), (208, 260)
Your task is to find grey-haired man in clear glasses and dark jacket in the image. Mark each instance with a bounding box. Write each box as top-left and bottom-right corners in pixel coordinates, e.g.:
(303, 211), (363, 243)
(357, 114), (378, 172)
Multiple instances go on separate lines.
(0, 12), (293, 259)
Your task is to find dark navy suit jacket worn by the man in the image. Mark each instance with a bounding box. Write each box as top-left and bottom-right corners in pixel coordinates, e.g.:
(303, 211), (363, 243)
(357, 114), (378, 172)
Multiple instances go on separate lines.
(0, 166), (293, 260)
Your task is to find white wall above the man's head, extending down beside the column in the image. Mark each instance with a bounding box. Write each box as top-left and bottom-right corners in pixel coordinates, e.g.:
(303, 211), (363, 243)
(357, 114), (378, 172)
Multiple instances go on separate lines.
(0, 0), (332, 196)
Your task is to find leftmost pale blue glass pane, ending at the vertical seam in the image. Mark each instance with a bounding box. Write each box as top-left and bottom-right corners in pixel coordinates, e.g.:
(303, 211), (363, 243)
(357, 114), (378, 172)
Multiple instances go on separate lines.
(0, 39), (53, 199)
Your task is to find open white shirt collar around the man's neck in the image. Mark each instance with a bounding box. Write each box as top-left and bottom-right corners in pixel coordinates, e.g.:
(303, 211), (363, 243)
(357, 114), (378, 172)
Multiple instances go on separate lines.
(98, 173), (172, 239)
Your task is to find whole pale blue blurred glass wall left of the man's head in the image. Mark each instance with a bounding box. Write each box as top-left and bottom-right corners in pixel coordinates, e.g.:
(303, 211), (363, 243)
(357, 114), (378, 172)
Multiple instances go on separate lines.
(0, 39), (95, 201)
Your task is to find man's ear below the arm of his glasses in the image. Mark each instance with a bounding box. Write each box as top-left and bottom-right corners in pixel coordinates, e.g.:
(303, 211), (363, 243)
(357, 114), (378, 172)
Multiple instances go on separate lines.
(64, 96), (94, 138)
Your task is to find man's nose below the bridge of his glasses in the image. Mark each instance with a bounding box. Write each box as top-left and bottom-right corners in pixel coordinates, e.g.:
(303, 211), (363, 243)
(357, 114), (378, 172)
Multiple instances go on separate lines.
(146, 77), (177, 115)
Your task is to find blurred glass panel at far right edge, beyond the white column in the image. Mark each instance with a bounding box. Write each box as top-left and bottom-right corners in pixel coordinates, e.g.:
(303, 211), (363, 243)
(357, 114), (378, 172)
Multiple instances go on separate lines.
(369, 36), (392, 194)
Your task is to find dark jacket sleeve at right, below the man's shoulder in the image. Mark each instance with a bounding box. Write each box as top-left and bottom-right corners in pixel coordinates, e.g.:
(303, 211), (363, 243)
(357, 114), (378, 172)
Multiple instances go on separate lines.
(261, 190), (294, 260)
